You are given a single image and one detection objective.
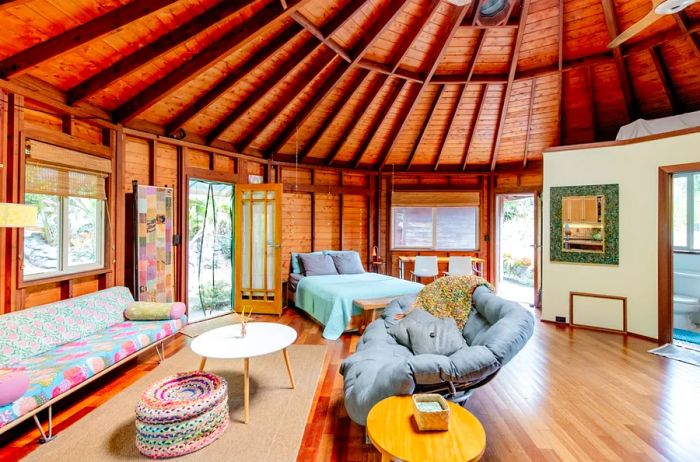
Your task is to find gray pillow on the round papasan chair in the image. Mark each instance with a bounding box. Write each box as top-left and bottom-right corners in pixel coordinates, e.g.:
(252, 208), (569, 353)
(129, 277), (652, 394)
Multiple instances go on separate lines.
(407, 318), (466, 356)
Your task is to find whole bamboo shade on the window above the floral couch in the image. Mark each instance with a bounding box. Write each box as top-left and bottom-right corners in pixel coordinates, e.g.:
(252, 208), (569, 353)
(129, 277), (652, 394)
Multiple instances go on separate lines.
(24, 140), (112, 201)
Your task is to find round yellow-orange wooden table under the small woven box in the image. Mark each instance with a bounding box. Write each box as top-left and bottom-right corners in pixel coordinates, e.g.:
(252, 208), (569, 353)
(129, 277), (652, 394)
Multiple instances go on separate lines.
(367, 396), (486, 462)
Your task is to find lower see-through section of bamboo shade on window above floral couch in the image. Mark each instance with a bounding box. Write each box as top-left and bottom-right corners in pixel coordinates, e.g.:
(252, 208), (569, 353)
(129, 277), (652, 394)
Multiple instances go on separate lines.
(24, 163), (107, 200)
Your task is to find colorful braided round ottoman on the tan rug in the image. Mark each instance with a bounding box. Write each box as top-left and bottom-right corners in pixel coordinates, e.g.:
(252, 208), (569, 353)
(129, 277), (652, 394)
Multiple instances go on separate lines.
(136, 372), (229, 459)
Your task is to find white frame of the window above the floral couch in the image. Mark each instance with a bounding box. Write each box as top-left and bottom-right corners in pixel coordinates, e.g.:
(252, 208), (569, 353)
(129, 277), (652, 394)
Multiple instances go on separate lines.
(22, 193), (107, 282)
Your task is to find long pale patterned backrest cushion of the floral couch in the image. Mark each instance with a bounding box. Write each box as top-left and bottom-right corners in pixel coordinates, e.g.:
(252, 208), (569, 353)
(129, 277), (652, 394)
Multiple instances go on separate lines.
(0, 287), (134, 367)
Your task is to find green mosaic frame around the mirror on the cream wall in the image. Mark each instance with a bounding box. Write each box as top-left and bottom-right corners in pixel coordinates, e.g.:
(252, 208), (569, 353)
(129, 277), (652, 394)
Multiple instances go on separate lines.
(549, 184), (620, 265)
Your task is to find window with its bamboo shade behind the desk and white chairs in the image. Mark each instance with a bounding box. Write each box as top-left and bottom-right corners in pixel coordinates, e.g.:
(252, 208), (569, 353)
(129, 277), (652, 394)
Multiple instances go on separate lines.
(391, 192), (479, 250)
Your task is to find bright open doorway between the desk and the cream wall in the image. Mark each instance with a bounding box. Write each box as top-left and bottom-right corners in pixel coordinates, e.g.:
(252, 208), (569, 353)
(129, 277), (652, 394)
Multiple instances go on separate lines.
(496, 194), (537, 306)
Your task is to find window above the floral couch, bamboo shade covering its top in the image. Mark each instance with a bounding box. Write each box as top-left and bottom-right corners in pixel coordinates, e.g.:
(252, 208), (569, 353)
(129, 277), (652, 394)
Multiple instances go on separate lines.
(23, 163), (106, 280)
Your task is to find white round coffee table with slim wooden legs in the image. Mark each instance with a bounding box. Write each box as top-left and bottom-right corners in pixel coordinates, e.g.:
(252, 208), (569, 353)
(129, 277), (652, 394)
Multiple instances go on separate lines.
(190, 322), (297, 423)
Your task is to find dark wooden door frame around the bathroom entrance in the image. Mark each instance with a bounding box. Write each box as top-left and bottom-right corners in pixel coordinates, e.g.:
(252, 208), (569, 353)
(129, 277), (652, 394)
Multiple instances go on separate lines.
(658, 162), (700, 345)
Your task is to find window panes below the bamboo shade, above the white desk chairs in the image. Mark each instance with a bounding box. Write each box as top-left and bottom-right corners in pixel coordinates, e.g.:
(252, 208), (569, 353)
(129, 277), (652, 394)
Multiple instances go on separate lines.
(392, 206), (479, 250)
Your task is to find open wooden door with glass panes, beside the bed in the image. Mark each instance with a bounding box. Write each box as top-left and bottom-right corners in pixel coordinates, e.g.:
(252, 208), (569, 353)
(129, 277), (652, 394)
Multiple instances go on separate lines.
(234, 184), (283, 314)
